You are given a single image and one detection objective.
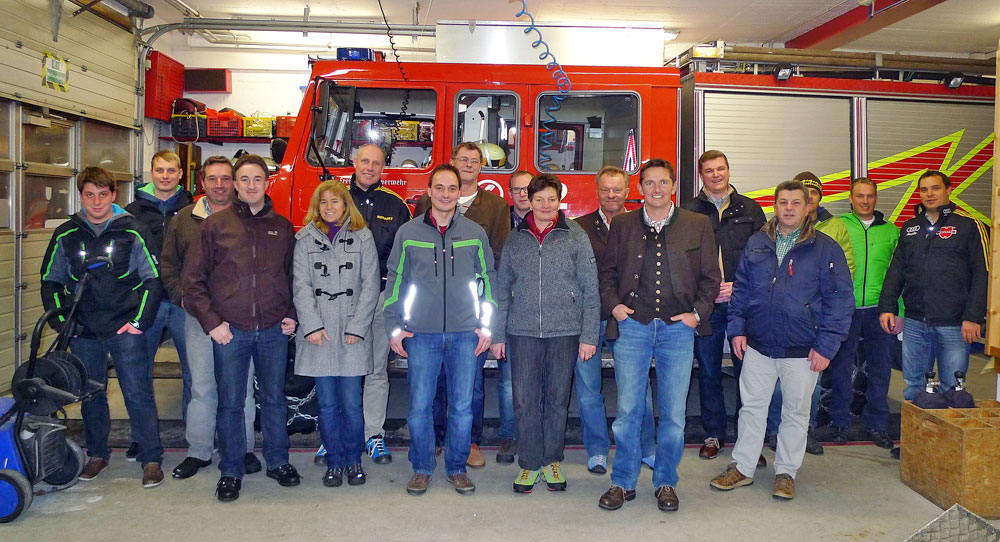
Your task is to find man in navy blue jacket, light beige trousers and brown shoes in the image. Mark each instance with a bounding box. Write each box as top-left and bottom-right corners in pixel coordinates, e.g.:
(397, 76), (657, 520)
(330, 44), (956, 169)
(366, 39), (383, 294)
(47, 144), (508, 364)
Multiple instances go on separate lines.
(711, 181), (854, 499)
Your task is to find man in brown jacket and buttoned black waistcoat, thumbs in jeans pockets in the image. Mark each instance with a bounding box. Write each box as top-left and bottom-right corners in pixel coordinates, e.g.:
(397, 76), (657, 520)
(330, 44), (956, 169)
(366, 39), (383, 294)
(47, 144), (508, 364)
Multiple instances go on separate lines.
(598, 158), (722, 511)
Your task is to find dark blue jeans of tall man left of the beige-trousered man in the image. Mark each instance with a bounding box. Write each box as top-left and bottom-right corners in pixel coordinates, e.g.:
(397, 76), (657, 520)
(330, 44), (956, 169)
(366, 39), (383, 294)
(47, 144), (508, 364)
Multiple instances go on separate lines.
(694, 302), (743, 441)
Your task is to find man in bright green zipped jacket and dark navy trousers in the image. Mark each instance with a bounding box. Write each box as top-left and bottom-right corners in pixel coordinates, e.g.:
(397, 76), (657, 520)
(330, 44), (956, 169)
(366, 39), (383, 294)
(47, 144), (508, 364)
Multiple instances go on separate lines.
(829, 177), (903, 449)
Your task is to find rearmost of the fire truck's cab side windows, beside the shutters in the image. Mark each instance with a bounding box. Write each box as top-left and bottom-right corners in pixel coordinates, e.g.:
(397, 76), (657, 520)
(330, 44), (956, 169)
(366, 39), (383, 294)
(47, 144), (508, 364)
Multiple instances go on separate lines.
(535, 92), (639, 172)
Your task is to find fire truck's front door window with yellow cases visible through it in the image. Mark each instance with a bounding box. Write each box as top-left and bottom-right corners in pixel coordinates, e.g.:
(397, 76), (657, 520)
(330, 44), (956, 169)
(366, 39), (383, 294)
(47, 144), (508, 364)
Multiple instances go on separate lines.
(351, 87), (437, 169)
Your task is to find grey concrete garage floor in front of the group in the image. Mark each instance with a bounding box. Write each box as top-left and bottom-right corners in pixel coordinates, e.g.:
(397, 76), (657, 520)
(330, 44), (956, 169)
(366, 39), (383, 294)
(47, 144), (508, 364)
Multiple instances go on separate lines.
(0, 445), (1000, 542)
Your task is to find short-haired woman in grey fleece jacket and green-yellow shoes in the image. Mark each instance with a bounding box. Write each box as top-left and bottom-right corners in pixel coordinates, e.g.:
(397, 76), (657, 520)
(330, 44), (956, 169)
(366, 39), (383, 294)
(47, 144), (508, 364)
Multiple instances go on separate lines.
(493, 174), (601, 493)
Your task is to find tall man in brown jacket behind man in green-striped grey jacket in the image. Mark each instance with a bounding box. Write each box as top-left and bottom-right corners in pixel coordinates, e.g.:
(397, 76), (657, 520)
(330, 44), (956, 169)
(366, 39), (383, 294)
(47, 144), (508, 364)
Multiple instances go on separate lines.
(413, 141), (513, 469)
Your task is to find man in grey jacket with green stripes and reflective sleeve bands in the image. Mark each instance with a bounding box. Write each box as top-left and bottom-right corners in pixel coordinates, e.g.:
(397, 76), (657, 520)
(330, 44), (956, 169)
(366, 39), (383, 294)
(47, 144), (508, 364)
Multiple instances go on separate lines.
(385, 164), (496, 495)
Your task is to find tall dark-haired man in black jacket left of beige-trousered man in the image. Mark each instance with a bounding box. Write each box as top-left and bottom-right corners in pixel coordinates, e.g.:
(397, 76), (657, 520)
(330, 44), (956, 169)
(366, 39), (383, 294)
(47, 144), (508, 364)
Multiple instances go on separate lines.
(684, 150), (766, 461)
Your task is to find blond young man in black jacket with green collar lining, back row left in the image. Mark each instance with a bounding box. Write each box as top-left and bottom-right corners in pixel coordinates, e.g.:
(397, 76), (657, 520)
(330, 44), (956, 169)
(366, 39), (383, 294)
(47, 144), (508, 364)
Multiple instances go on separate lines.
(125, 150), (193, 461)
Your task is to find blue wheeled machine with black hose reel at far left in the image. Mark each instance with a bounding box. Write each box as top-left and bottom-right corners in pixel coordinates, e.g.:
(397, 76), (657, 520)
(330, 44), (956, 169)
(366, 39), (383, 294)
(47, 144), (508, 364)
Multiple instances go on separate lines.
(0, 258), (111, 523)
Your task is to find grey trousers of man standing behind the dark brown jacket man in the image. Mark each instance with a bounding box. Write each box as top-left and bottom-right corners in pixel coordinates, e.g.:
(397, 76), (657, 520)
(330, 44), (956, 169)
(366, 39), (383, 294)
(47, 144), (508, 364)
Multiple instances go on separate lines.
(184, 314), (257, 461)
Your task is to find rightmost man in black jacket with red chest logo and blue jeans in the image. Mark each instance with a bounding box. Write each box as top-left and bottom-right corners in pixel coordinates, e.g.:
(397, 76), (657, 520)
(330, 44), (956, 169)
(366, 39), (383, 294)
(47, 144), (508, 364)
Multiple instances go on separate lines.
(879, 170), (989, 399)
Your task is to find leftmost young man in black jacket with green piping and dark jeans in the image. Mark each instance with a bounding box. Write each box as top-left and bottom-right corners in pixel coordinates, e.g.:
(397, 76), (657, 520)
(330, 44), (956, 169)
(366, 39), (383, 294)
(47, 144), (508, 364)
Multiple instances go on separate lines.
(41, 167), (163, 488)
